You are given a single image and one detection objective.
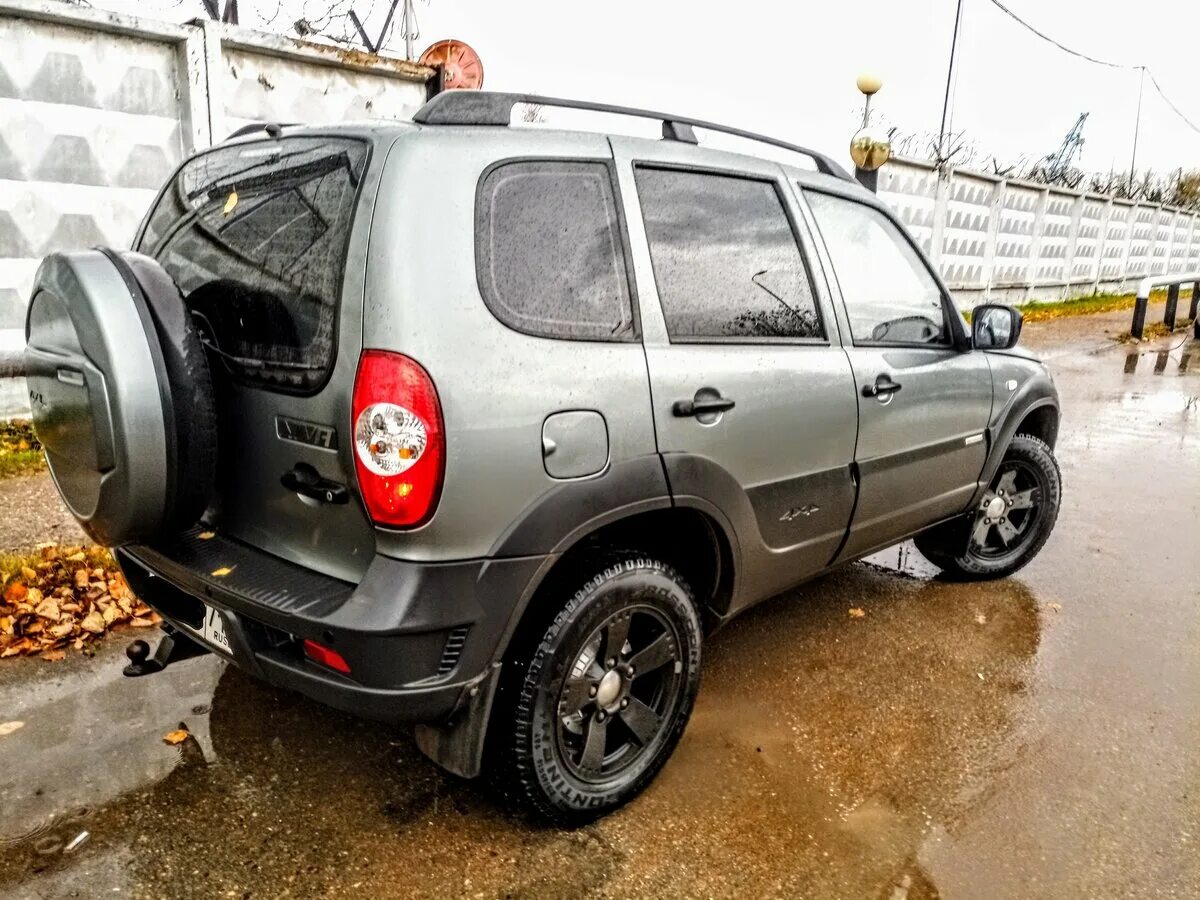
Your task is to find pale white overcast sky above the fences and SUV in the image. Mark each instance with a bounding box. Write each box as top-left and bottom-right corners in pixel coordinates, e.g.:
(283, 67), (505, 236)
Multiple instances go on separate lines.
(103, 0), (1200, 177)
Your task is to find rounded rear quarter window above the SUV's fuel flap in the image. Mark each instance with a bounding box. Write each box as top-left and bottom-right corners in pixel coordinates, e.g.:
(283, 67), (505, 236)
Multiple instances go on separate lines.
(475, 160), (635, 341)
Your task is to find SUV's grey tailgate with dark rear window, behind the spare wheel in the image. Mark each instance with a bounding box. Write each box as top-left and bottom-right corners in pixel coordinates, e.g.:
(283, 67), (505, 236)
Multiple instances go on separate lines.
(137, 132), (383, 581)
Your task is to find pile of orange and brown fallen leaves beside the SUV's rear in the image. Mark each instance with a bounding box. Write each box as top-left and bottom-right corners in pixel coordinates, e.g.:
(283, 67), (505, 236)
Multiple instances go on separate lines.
(0, 545), (161, 661)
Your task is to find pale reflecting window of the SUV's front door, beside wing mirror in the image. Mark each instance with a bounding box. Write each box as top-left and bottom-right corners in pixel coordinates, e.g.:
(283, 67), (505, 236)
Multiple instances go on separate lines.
(806, 193), (949, 343)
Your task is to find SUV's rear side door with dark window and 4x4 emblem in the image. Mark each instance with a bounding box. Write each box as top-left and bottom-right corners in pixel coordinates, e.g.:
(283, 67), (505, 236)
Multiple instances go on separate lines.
(613, 139), (857, 605)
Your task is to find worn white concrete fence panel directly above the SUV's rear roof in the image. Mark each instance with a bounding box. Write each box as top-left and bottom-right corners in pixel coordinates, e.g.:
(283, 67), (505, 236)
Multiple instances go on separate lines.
(216, 47), (426, 137)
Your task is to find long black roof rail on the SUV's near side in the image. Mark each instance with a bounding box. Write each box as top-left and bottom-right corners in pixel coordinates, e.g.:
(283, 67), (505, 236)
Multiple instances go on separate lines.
(413, 90), (853, 181)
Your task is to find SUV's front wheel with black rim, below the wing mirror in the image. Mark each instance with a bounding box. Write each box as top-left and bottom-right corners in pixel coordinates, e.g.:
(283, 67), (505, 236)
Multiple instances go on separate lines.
(914, 434), (1062, 580)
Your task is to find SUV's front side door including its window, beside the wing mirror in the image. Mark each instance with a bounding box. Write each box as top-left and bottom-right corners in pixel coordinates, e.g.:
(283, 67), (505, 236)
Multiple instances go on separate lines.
(804, 191), (992, 559)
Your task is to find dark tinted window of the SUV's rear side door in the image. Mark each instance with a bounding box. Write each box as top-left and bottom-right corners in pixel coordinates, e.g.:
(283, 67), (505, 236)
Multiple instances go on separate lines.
(637, 167), (822, 338)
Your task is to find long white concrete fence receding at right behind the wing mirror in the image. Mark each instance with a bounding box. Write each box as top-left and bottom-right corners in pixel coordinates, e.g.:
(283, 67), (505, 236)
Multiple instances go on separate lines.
(880, 160), (1200, 308)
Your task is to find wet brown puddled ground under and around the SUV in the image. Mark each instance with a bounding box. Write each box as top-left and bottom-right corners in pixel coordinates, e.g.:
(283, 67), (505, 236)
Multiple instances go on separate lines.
(0, 313), (1200, 900)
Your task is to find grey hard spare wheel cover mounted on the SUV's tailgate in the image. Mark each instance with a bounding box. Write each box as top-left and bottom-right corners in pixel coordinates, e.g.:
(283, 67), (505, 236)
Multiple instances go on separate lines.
(25, 250), (175, 546)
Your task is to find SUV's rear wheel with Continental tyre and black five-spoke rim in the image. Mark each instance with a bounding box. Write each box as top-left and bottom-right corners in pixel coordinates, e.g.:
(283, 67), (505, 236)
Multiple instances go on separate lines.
(494, 557), (701, 826)
